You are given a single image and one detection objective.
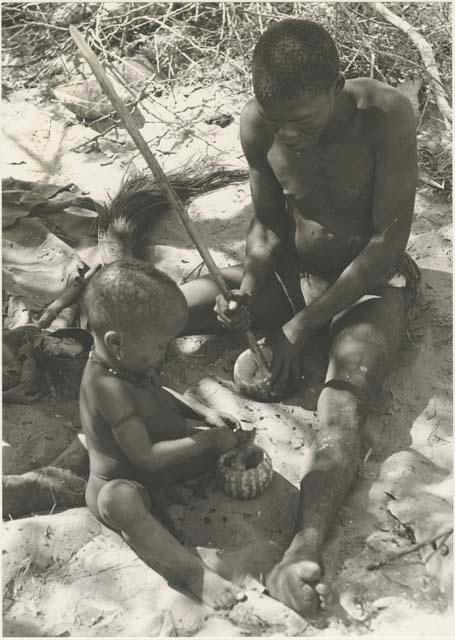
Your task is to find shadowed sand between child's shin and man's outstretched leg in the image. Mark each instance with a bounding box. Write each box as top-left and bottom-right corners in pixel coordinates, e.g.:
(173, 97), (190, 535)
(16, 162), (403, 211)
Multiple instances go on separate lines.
(170, 470), (299, 584)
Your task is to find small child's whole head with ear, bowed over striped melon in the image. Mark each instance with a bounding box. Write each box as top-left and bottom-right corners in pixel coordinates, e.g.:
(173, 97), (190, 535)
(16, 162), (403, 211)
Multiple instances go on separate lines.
(83, 259), (188, 372)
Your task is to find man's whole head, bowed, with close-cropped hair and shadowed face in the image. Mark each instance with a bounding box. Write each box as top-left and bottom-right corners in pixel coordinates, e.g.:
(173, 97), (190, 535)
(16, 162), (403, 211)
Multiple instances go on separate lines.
(253, 19), (344, 147)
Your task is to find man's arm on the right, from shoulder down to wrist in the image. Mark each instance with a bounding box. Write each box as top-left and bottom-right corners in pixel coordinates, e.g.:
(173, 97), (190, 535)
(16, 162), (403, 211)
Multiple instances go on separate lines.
(292, 95), (417, 346)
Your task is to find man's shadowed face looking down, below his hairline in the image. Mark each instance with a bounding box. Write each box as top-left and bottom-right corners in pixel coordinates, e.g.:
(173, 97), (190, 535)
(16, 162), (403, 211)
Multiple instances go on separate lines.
(259, 90), (335, 153)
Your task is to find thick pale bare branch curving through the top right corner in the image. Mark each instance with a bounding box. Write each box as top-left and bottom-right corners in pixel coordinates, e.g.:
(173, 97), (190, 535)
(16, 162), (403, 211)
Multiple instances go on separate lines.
(369, 2), (452, 128)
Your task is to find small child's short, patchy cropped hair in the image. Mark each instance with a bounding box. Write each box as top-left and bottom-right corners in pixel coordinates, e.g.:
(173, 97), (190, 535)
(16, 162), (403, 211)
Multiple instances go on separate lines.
(83, 258), (187, 334)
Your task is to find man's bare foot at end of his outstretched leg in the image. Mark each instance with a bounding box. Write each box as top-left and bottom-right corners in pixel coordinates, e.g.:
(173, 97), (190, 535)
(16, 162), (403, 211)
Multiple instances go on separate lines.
(266, 559), (331, 618)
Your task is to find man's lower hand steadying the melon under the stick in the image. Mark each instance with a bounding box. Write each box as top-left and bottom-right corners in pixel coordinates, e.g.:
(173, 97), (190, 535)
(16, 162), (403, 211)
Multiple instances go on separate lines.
(267, 323), (303, 397)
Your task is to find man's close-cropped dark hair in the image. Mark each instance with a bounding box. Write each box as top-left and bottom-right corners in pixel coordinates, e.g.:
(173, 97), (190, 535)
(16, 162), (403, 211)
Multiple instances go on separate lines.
(253, 19), (340, 105)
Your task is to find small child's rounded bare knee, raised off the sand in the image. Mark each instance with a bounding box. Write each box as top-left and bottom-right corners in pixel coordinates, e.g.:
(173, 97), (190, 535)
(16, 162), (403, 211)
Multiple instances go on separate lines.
(97, 479), (150, 531)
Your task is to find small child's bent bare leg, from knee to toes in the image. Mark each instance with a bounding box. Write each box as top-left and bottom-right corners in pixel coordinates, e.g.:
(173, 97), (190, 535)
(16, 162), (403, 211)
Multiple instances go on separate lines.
(91, 479), (240, 609)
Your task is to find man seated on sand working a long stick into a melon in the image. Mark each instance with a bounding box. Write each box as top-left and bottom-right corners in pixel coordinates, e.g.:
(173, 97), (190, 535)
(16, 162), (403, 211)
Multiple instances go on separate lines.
(182, 20), (419, 615)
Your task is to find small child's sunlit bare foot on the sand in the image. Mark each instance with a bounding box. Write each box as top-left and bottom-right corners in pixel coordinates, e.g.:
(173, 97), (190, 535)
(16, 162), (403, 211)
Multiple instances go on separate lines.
(186, 566), (245, 609)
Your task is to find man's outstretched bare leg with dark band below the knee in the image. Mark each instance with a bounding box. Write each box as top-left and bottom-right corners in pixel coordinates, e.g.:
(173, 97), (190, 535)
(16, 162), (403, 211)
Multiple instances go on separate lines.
(266, 288), (405, 616)
